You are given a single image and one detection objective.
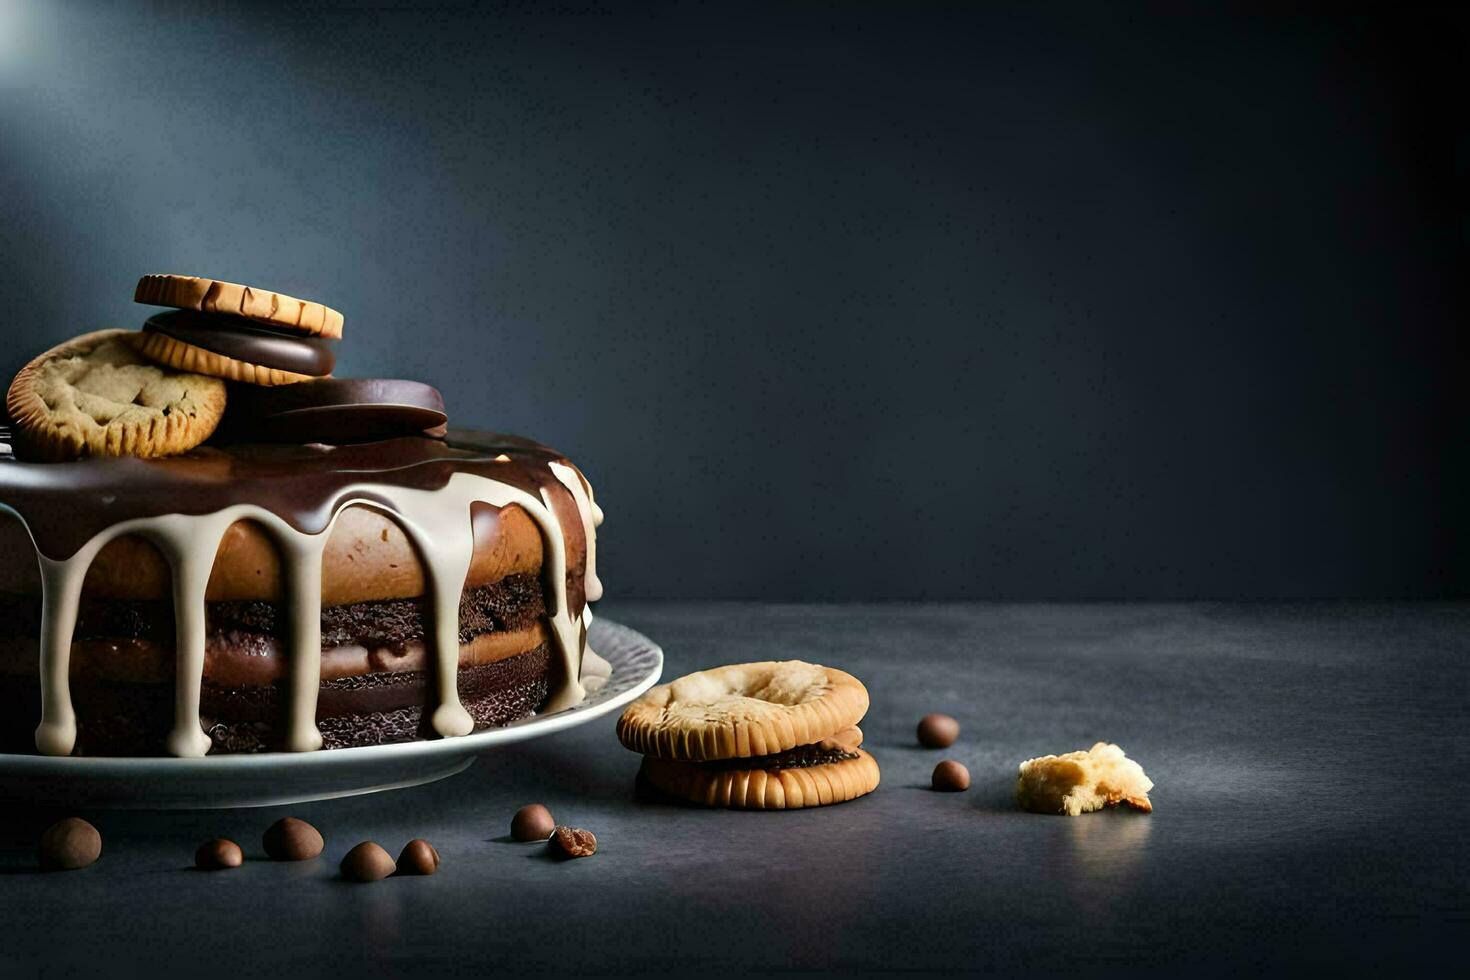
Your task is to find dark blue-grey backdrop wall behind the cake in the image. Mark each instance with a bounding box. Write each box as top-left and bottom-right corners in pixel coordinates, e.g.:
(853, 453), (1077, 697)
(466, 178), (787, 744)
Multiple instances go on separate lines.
(0, 0), (1470, 598)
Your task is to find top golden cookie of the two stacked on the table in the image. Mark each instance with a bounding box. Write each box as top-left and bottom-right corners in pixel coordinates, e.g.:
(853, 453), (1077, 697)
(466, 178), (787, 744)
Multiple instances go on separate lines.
(617, 660), (867, 761)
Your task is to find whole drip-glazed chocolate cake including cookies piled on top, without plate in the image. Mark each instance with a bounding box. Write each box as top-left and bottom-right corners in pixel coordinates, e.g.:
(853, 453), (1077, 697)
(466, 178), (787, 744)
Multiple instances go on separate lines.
(0, 276), (607, 757)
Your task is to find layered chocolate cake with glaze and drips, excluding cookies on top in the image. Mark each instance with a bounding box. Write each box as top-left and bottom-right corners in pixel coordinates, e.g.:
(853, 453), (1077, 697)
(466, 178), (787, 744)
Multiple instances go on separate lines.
(0, 432), (601, 755)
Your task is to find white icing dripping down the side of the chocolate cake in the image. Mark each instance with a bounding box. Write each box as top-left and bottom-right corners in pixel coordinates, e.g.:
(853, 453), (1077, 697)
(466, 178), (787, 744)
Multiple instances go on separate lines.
(0, 464), (590, 757)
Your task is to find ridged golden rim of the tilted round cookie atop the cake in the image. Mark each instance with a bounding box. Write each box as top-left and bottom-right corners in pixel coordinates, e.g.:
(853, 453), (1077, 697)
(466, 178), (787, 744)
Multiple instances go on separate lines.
(6, 329), (225, 463)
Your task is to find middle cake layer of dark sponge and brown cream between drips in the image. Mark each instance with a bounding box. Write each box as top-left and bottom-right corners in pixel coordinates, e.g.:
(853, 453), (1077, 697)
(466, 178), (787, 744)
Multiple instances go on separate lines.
(0, 574), (547, 686)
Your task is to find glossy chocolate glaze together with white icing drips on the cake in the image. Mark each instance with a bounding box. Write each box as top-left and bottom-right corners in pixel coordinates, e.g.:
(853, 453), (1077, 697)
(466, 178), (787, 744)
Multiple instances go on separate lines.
(0, 432), (601, 755)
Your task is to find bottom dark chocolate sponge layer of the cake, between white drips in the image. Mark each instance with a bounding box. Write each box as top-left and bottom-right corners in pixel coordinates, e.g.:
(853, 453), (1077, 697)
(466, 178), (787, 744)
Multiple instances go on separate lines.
(0, 644), (551, 755)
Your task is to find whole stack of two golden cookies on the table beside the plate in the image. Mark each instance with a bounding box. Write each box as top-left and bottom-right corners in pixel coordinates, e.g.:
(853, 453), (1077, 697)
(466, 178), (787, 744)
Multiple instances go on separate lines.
(617, 660), (879, 810)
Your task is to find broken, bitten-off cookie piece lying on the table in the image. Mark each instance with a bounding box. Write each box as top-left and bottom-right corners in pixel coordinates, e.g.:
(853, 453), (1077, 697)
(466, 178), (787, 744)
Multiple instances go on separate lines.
(1016, 742), (1154, 817)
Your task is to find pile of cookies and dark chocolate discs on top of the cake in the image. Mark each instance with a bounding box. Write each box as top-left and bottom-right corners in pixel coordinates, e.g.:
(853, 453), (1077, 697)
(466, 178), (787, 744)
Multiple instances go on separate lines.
(6, 275), (447, 461)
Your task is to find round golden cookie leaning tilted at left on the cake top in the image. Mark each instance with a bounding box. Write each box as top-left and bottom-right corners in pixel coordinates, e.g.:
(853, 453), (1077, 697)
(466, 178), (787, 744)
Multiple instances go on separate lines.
(6, 331), (225, 461)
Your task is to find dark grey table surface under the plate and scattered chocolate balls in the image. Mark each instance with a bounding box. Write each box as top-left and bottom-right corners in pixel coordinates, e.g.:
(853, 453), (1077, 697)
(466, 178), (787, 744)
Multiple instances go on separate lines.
(0, 602), (1470, 976)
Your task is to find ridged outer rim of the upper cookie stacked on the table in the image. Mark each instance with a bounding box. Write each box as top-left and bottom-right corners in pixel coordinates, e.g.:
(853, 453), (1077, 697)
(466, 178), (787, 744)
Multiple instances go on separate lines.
(617, 661), (867, 763)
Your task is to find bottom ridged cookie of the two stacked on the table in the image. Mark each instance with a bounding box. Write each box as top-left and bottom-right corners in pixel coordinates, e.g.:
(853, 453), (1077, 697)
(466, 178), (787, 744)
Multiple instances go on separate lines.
(641, 749), (881, 810)
